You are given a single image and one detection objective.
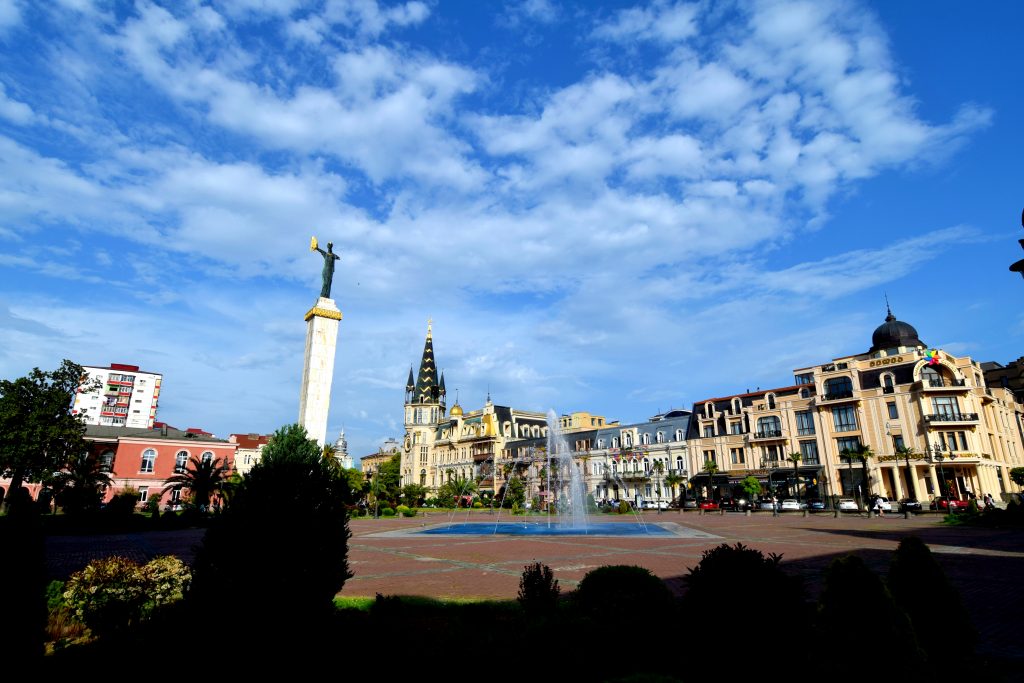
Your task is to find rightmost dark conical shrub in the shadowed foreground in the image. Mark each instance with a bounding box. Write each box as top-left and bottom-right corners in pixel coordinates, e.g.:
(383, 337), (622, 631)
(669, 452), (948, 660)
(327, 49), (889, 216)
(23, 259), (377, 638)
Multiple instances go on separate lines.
(887, 537), (977, 673)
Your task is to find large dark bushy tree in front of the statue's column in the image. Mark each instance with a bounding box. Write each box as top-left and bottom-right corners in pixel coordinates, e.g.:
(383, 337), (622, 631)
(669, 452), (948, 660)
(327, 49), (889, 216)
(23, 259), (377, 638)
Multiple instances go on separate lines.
(188, 424), (351, 652)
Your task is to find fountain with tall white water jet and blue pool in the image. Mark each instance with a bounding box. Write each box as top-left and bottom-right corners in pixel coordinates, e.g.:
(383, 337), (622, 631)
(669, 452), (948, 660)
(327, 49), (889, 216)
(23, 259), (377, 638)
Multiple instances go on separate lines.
(418, 411), (680, 536)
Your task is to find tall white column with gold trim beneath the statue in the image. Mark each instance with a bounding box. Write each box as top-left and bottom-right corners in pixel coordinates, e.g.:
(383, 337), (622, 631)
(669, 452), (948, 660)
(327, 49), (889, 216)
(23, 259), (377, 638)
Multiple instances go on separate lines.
(299, 297), (341, 446)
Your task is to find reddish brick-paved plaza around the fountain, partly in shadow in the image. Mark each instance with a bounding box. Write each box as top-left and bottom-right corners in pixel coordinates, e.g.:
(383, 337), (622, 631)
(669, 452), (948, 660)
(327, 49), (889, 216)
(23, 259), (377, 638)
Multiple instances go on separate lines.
(41, 511), (1024, 661)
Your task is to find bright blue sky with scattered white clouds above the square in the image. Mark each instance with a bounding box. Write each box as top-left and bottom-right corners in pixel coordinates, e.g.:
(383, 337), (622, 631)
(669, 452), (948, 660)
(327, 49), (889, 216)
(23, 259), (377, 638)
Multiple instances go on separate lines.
(0, 0), (1024, 457)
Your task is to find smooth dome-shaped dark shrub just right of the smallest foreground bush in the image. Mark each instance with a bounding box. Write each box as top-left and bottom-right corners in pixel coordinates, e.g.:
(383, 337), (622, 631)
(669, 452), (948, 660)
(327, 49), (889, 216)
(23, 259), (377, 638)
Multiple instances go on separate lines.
(573, 564), (674, 624)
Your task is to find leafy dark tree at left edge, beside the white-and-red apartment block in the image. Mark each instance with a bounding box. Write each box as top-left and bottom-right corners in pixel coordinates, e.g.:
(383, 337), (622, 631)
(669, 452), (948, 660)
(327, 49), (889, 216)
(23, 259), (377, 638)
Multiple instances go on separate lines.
(0, 359), (91, 501)
